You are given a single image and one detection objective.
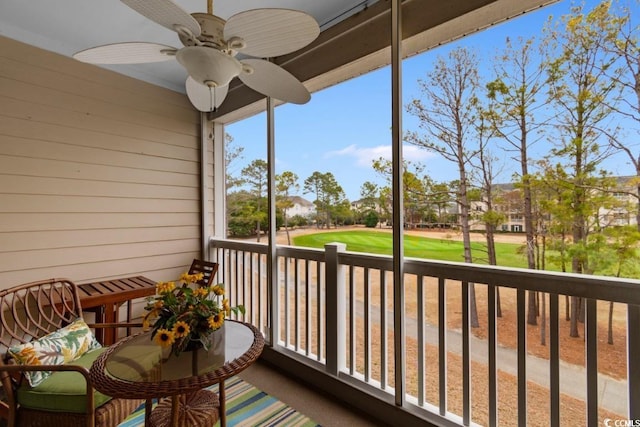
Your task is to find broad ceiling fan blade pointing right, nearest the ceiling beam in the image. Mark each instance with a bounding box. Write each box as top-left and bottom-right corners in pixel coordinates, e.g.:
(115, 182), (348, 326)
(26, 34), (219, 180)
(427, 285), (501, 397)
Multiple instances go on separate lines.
(224, 9), (320, 58)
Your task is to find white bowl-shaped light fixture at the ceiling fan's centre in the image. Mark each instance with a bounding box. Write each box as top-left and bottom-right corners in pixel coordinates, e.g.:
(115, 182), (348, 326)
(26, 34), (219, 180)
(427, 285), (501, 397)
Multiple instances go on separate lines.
(176, 46), (242, 86)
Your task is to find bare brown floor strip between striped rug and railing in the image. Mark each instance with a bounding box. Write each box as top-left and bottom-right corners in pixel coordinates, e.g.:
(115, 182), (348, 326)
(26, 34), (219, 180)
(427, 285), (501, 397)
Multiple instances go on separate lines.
(240, 360), (385, 427)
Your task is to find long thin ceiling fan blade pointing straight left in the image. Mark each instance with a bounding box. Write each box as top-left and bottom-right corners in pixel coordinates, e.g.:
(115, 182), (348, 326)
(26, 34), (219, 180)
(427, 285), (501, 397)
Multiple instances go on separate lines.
(73, 42), (177, 64)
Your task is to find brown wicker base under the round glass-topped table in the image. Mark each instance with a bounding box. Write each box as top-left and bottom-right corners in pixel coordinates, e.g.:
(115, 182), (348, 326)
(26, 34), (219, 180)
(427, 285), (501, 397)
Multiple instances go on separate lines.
(149, 390), (220, 427)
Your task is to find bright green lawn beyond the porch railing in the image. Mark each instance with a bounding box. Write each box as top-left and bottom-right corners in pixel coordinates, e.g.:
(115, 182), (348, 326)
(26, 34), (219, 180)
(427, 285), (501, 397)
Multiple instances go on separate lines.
(293, 230), (527, 268)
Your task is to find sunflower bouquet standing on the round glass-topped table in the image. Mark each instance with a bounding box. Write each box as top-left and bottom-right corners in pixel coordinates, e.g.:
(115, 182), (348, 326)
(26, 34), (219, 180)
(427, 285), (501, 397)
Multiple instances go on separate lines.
(143, 273), (245, 355)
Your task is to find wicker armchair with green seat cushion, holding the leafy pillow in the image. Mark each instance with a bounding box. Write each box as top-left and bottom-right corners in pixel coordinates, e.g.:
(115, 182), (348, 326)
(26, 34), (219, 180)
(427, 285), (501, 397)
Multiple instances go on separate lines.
(0, 279), (143, 427)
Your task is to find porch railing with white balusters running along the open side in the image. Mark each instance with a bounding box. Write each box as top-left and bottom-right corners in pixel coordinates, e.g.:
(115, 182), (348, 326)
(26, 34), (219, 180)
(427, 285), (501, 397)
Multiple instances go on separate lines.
(211, 240), (640, 426)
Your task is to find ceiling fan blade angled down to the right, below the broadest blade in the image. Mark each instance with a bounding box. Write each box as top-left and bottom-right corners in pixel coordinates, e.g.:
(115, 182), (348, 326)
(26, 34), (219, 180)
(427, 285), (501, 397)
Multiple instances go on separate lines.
(238, 59), (311, 104)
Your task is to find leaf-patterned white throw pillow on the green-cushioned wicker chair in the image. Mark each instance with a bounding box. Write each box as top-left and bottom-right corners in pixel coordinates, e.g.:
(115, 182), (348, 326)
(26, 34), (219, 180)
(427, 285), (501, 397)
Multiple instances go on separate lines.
(9, 318), (101, 387)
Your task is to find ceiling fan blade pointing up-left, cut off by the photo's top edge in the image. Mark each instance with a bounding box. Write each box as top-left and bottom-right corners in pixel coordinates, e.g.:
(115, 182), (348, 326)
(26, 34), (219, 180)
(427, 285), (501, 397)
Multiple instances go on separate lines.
(120, 0), (200, 36)
